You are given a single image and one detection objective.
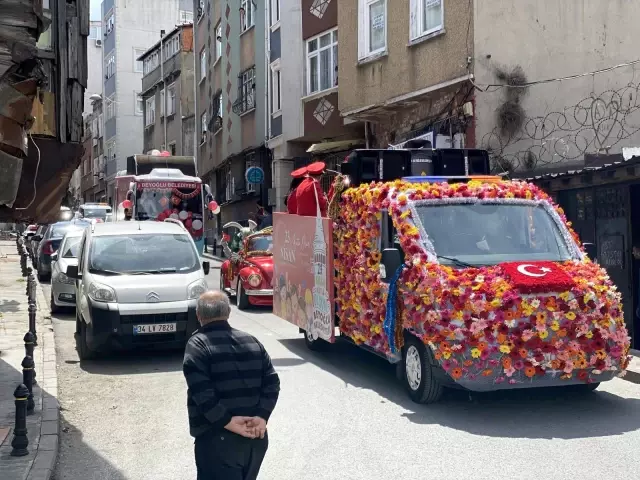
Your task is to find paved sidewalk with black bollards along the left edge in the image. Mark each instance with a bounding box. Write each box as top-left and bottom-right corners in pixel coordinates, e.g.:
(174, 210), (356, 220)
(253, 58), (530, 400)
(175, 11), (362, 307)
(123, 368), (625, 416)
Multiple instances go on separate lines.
(0, 240), (59, 480)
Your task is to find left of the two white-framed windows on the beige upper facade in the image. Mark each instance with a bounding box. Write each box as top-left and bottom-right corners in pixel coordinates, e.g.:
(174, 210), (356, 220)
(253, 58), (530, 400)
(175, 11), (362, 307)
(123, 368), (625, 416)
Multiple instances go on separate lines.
(358, 0), (387, 59)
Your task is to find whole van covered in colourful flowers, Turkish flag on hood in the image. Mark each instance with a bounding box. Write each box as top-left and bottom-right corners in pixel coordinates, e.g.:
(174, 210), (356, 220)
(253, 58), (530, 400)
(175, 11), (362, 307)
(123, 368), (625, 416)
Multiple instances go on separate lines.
(274, 158), (630, 403)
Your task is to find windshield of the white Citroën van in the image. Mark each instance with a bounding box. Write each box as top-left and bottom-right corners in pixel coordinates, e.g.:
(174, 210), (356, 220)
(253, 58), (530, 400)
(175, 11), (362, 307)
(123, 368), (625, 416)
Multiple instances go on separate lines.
(89, 234), (200, 274)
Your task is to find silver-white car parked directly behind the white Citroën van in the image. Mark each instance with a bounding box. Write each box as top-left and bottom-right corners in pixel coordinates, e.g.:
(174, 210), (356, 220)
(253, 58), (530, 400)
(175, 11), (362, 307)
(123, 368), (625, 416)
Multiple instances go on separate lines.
(51, 229), (83, 313)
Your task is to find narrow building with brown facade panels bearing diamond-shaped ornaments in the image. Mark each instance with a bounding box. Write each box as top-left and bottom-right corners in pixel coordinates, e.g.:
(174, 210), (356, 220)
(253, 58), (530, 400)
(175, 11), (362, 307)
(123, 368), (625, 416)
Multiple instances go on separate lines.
(267, 0), (365, 210)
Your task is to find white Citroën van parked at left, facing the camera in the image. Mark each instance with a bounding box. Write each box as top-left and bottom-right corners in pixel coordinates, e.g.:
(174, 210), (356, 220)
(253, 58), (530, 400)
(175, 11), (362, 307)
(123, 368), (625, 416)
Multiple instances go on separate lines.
(66, 222), (210, 359)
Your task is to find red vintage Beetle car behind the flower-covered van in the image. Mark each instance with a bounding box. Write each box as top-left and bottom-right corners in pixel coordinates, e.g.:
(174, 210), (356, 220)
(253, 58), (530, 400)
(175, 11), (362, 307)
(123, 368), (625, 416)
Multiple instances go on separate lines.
(220, 229), (273, 310)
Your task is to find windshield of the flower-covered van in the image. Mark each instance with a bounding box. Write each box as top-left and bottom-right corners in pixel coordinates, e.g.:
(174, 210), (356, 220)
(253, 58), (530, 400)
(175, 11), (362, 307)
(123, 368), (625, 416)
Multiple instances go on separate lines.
(417, 203), (572, 266)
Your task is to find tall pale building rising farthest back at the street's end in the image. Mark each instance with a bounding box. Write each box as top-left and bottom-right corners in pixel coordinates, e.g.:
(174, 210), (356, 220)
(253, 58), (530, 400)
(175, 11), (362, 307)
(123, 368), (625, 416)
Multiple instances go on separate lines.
(100, 0), (193, 202)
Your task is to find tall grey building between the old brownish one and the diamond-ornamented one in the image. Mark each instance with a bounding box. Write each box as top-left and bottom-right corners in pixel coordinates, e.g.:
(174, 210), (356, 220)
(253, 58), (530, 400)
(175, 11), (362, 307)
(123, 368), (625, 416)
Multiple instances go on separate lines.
(194, 0), (271, 231)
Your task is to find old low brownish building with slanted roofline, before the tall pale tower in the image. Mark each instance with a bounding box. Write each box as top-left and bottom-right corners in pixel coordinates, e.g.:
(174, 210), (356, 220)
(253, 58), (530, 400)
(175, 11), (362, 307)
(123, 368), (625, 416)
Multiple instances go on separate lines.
(138, 23), (195, 156)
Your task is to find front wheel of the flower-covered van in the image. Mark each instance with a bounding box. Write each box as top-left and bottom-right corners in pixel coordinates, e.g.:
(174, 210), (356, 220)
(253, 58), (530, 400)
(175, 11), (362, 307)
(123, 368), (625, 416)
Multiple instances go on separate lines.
(402, 336), (443, 403)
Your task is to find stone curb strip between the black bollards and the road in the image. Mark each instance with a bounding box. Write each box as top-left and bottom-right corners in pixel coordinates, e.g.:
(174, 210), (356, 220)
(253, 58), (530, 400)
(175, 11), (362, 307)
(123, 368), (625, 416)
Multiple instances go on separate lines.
(27, 282), (60, 480)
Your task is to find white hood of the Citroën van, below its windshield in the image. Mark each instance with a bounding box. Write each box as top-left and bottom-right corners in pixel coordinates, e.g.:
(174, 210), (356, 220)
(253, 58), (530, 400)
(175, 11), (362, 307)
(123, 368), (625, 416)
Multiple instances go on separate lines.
(93, 270), (205, 303)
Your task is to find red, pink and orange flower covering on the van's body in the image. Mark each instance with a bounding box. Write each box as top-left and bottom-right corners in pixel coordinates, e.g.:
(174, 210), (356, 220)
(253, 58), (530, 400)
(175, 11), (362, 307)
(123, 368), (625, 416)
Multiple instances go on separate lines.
(334, 180), (630, 385)
